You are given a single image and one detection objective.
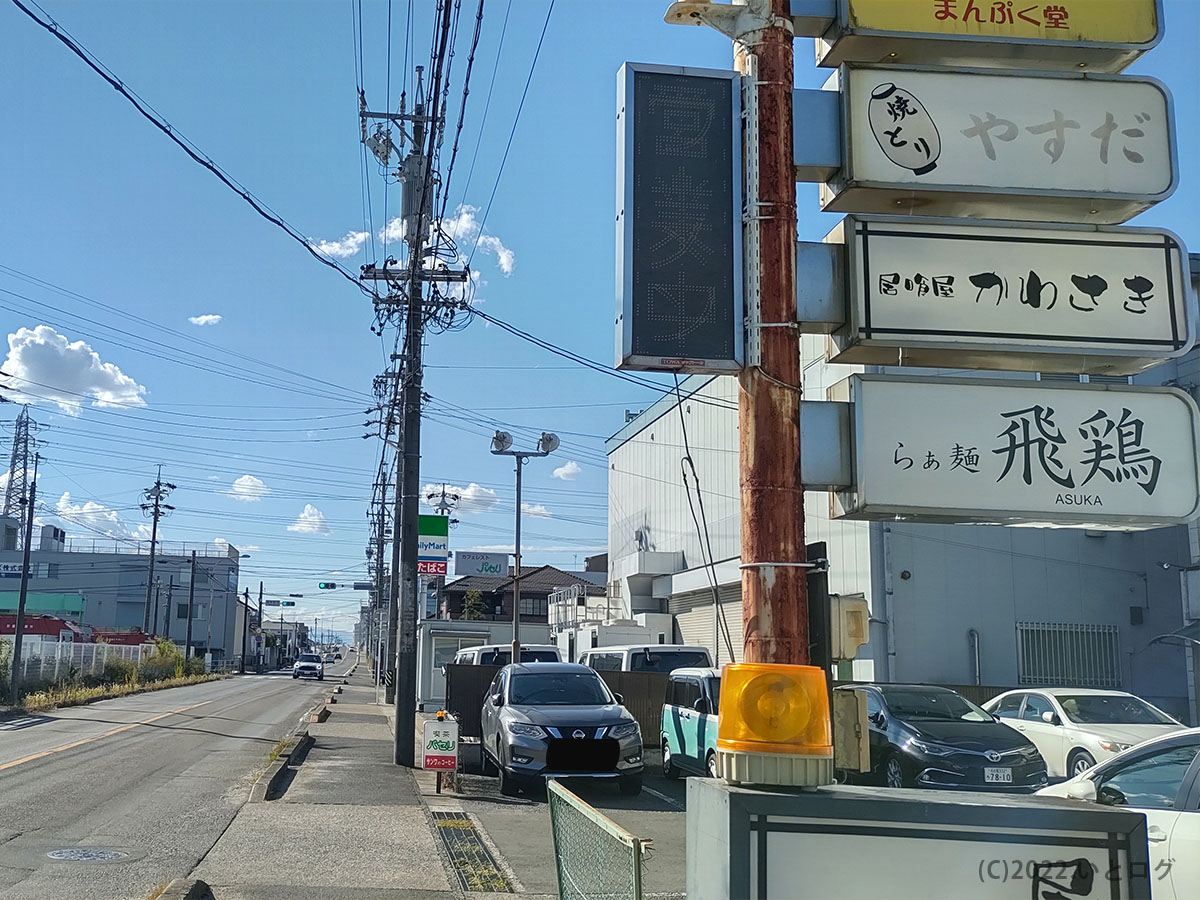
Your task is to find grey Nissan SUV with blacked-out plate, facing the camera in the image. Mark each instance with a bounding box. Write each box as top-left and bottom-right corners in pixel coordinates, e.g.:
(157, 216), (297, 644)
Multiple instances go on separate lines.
(481, 662), (643, 797)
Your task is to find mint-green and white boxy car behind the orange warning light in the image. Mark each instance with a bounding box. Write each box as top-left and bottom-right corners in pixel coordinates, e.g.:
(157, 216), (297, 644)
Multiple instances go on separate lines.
(660, 667), (721, 778)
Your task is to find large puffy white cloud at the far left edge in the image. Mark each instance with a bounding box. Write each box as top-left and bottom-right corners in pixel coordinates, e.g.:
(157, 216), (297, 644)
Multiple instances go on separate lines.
(4, 325), (146, 415)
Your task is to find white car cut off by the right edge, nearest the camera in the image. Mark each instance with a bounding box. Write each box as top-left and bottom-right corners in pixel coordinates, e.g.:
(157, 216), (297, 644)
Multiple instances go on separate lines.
(1038, 728), (1200, 900)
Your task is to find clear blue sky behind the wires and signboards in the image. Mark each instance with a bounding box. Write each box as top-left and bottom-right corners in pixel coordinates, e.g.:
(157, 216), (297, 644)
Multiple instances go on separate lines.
(0, 0), (1200, 629)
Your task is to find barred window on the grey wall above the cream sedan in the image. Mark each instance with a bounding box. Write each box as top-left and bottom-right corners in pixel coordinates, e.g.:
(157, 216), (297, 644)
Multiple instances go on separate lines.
(1016, 622), (1121, 688)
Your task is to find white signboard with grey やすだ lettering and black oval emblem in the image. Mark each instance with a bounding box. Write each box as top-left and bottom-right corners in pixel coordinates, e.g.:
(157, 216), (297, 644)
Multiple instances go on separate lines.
(821, 66), (1177, 224)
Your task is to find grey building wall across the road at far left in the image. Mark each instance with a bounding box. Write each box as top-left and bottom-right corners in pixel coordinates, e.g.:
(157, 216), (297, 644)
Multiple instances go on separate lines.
(0, 535), (240, 659)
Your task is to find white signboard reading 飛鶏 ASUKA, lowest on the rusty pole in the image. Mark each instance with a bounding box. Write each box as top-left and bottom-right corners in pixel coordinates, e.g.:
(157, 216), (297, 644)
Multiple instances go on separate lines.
(830, 376), (1200, 529)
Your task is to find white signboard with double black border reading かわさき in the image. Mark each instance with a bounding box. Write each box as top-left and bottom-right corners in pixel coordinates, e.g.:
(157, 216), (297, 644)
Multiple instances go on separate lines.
(827, 216), (1196, 374)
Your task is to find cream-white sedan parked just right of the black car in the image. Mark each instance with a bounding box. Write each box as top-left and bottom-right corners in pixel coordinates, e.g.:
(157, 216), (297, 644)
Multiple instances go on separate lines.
(984, 688), (1183, 778)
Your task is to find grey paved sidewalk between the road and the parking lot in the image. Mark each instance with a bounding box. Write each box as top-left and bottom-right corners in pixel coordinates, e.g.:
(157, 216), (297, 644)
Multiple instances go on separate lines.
(191, 666), (463, 900)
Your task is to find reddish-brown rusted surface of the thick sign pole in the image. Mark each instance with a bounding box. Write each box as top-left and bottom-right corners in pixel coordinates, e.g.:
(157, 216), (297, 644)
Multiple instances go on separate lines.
(738, 0), (809, 665)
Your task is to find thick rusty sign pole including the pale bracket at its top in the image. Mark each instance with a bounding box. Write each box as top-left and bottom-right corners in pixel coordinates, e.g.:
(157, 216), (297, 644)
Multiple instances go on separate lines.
(666, 0), (810, 665)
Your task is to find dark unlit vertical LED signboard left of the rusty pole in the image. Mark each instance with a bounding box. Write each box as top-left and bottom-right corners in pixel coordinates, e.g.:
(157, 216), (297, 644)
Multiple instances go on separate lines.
(617, 62), (743, 372)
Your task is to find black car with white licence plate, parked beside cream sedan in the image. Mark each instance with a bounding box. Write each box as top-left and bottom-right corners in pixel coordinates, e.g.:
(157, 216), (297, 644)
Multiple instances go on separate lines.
(838, 684), (1046, 793)
